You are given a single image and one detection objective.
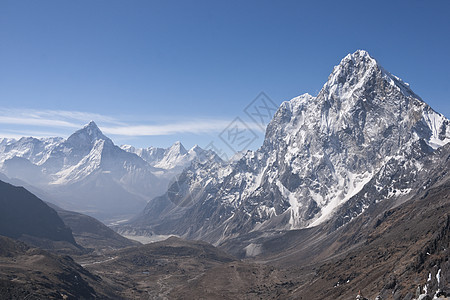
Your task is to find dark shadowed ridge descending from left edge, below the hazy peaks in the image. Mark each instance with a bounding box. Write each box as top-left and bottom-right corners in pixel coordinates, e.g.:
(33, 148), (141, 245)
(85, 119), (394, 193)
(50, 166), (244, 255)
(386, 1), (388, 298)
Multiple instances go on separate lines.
(0, 180), (139, 255)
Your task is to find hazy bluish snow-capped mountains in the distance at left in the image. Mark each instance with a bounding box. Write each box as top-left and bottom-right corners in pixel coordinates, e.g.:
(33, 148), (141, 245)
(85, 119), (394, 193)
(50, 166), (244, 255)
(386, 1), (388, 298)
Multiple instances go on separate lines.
(0, 122), (220, 220)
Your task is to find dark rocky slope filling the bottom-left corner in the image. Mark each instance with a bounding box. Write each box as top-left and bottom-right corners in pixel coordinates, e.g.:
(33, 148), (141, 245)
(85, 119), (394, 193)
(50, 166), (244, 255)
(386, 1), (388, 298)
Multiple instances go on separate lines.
(0, 236), (121, 299)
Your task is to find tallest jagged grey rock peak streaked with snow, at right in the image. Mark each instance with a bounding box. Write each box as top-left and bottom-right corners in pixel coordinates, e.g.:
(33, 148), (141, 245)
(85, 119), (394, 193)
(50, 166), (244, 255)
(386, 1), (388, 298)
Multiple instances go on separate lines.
(128, 50), (450, 244)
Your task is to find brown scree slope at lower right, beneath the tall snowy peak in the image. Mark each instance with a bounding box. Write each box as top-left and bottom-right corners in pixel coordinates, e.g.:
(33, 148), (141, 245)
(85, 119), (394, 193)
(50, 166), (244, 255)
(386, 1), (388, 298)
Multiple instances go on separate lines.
(270, 144), (450, 299)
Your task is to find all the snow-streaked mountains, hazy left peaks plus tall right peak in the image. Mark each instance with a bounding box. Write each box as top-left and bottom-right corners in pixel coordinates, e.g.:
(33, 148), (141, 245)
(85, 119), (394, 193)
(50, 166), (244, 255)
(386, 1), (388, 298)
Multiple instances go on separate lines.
(0, 50), (450, 244)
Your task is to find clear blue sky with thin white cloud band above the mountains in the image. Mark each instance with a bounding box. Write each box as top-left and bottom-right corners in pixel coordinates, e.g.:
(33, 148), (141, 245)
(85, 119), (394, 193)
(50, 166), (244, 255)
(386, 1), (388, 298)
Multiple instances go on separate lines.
(0, 0), (450, 157)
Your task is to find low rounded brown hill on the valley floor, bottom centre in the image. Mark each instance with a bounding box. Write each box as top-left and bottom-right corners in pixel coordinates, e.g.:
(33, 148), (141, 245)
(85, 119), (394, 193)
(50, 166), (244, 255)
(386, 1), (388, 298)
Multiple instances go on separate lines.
(80, 238), (300, 299)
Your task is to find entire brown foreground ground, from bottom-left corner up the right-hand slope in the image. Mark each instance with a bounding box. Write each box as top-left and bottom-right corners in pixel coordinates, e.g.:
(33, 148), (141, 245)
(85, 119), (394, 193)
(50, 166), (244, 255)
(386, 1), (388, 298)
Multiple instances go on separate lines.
(0, 148), (450, 299)
